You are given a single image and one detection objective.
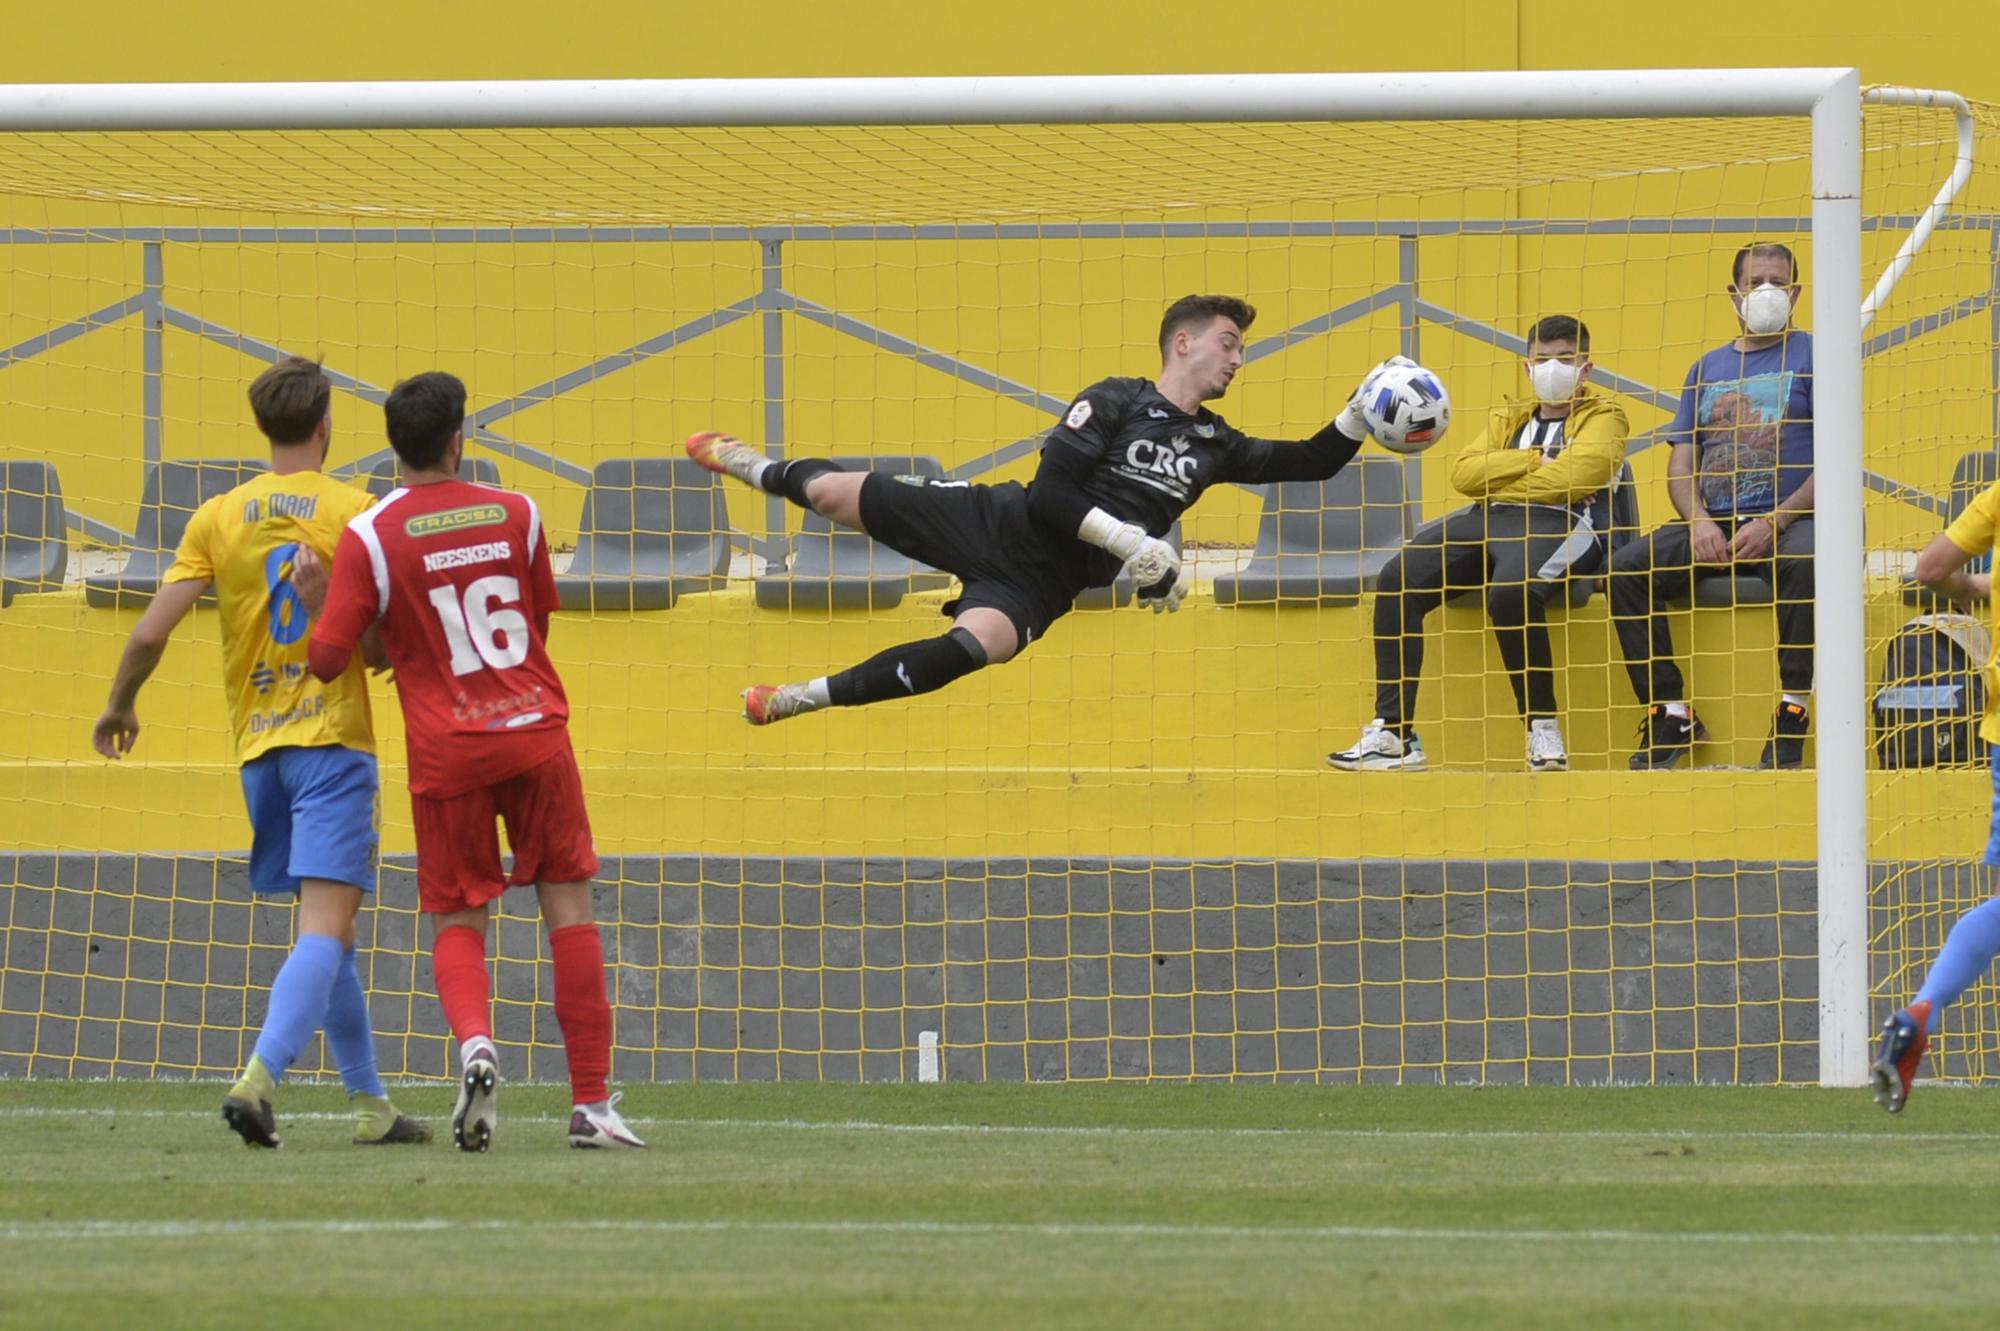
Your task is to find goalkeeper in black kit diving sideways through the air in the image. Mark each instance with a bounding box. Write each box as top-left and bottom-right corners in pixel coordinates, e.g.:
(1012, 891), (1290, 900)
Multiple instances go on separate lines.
(688, 296), (1408, 725)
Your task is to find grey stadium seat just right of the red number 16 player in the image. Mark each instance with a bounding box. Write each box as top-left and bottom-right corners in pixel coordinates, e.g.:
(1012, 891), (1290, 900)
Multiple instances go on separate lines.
(556, 458), (732, 610)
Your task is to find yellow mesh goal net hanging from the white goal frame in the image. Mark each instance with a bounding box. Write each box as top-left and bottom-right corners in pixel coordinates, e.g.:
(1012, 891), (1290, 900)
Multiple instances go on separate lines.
(0, 76), (2000, 1083)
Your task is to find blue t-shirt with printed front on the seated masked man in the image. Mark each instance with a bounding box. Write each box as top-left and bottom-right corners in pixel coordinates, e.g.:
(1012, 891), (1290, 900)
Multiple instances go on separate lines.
(1666, 332), (1812, 518)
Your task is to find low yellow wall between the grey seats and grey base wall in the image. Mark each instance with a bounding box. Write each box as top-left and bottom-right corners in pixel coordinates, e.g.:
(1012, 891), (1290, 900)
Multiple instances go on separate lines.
(0, 588), (1986, 861)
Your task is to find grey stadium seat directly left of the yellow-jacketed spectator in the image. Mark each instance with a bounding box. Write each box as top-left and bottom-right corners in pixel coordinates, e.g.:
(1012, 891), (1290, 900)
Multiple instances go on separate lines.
(1216, 458), (1404, 606)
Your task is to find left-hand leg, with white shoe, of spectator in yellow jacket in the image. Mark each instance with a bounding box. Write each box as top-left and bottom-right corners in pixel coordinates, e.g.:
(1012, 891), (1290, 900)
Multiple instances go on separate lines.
(1326, 506), (1480, 771)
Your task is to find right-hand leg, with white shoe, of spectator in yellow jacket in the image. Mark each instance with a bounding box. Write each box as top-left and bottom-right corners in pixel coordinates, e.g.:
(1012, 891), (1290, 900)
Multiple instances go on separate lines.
(1486, 504), (1596, 771)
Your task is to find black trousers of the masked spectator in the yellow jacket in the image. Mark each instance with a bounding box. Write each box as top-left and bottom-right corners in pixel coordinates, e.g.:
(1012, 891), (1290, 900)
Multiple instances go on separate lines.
(1374, 504), (1602, 725)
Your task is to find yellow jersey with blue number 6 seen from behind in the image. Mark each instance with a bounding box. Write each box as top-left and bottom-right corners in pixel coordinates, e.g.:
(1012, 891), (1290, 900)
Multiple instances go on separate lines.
(164, 472), (374, 763)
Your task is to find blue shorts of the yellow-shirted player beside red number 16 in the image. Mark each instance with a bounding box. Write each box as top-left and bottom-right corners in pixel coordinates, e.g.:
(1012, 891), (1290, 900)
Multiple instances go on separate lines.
(244, 743), (380, 895)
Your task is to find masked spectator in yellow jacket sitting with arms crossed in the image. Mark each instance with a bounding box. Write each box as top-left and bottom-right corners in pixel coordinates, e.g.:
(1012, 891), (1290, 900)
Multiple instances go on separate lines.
(1326, 314), (1632, 771)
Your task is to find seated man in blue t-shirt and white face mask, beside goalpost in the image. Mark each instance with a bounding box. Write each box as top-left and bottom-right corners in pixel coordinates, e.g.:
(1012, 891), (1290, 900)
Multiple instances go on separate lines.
(1610, 244), (1812, 769)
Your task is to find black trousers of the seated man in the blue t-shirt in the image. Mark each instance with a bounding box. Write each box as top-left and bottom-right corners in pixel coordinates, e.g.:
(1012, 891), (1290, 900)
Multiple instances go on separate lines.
(1610, 518), (1812, 703)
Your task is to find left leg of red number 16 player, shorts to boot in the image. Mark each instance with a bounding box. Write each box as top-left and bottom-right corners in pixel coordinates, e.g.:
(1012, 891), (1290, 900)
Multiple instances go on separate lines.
(410, 785), (506, 1151)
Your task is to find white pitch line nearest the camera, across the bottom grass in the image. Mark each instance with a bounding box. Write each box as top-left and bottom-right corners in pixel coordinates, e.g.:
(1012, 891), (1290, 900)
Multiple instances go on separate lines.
(0, 1219), (2000, 1247)
